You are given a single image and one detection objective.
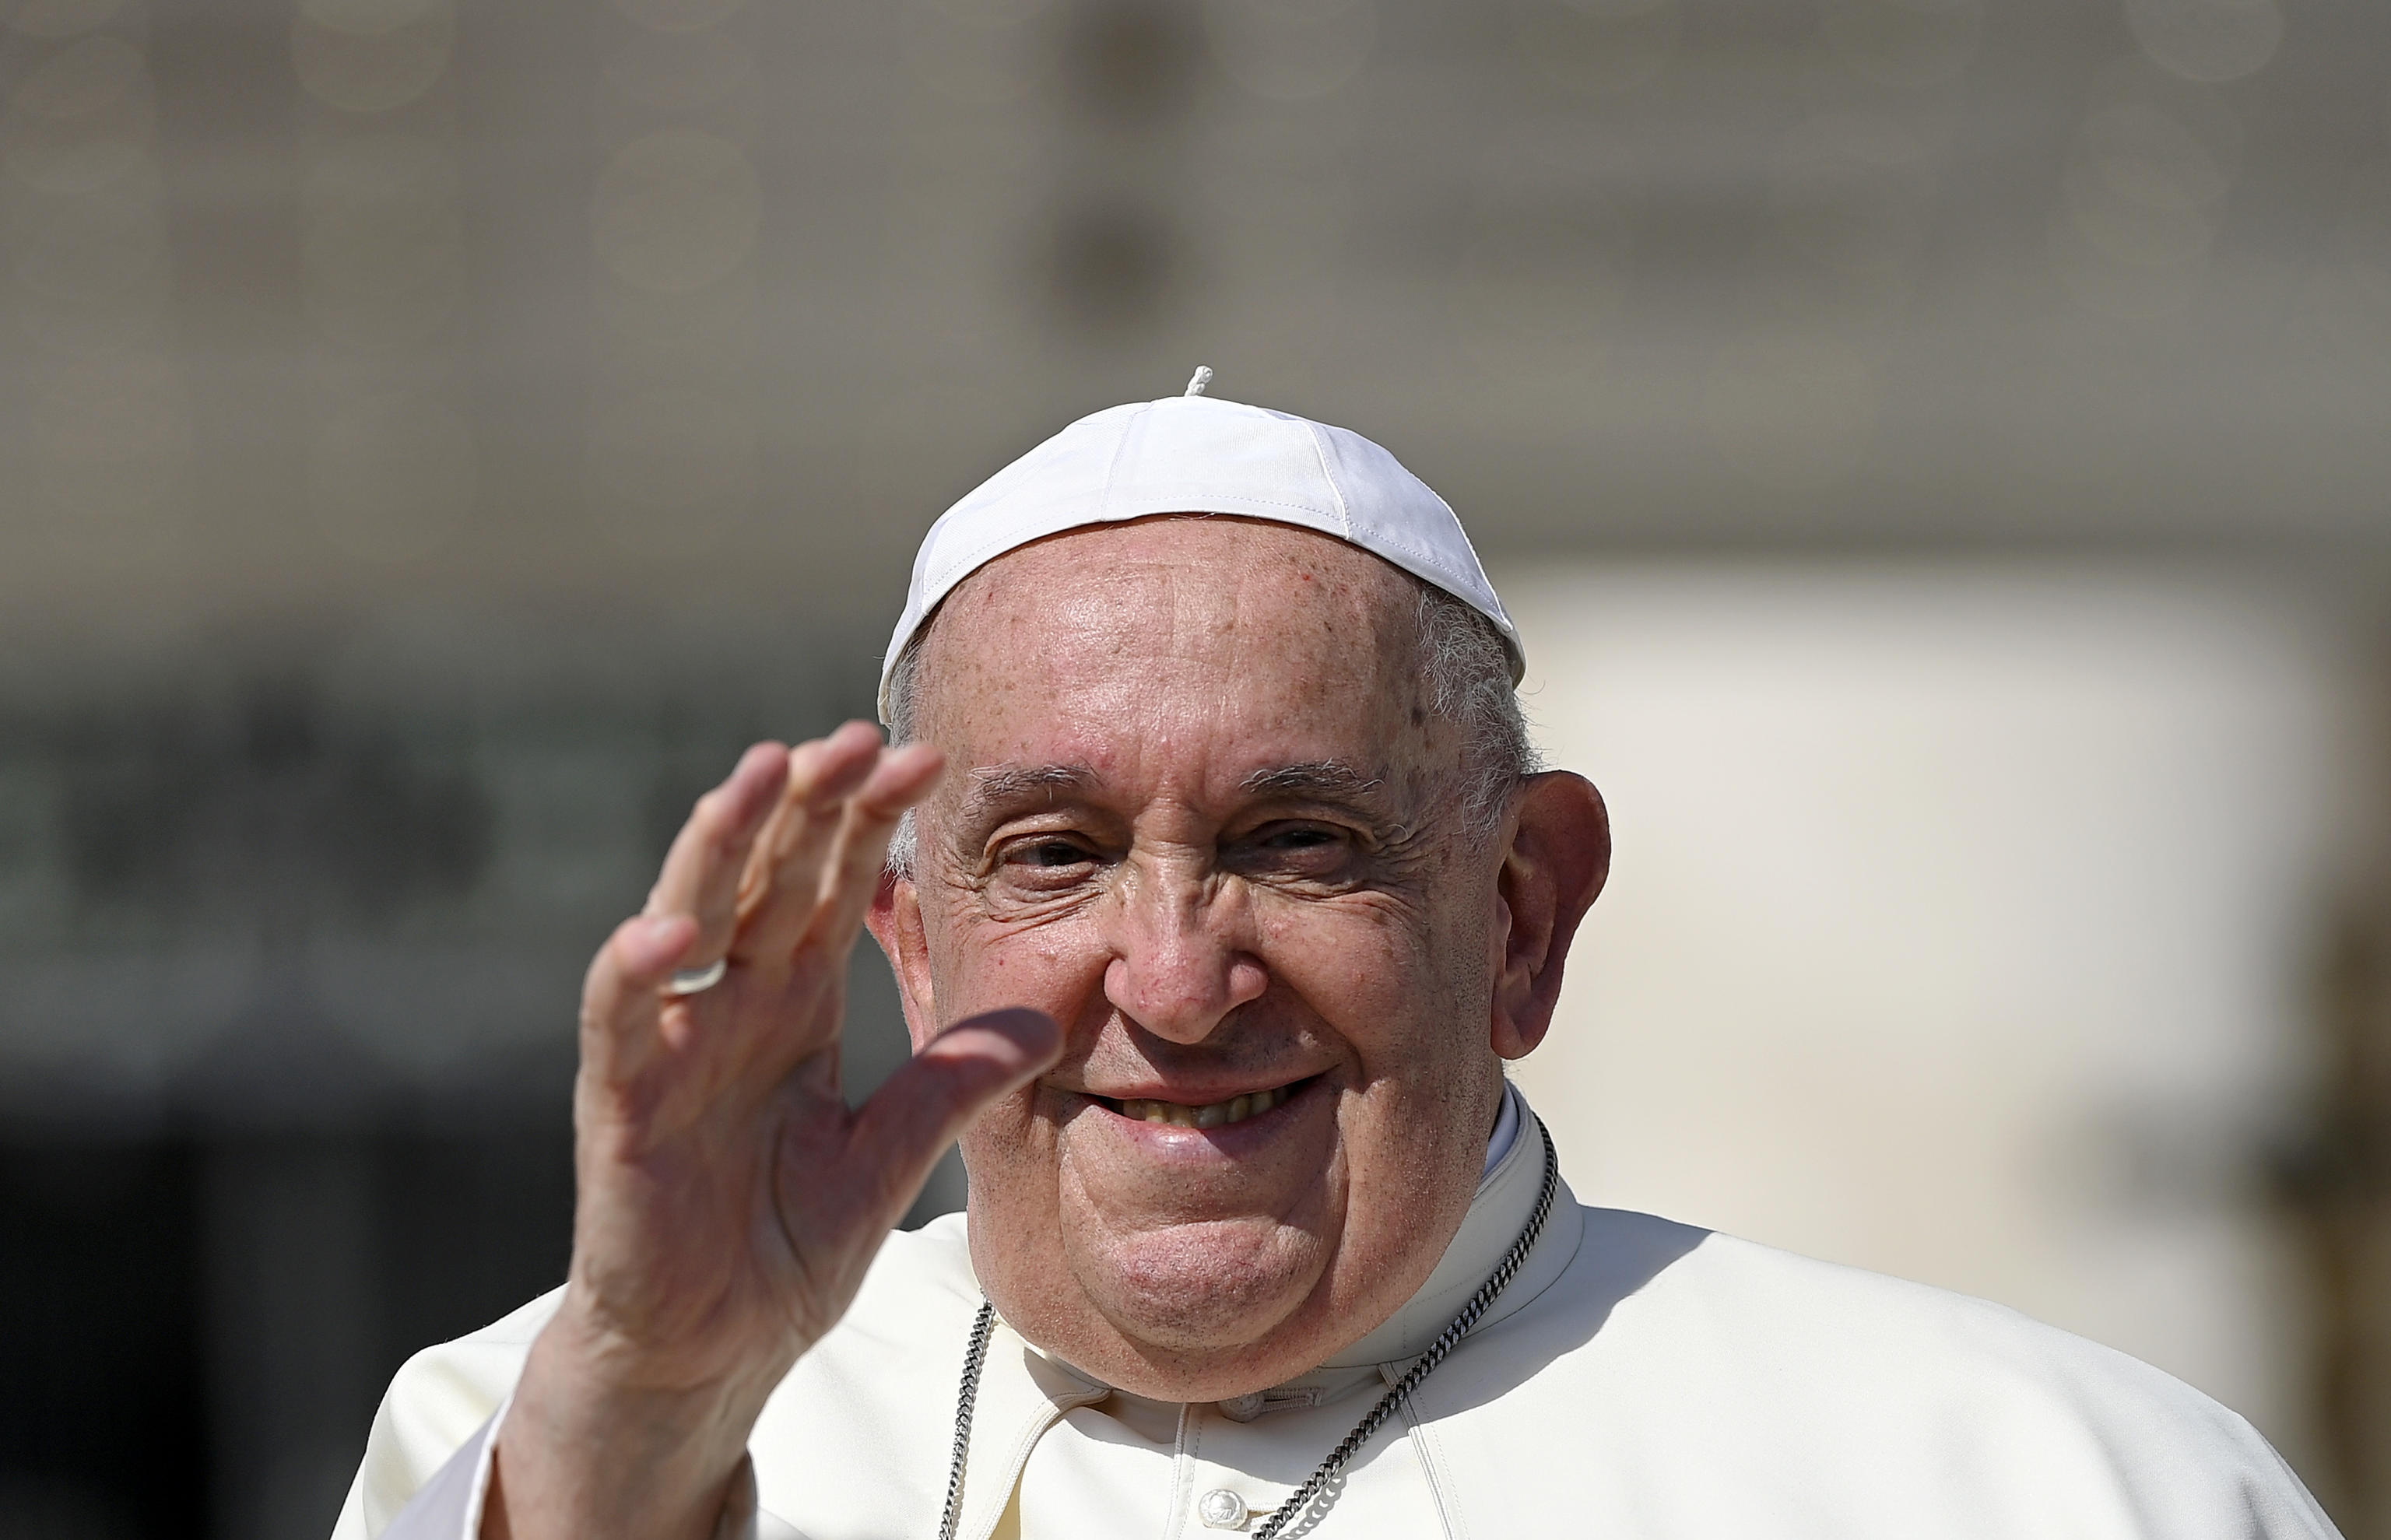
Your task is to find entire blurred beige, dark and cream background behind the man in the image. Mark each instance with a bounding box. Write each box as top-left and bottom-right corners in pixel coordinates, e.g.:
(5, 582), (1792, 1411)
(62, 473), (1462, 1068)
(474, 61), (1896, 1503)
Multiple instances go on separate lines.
(0, 0), (2391, 1540)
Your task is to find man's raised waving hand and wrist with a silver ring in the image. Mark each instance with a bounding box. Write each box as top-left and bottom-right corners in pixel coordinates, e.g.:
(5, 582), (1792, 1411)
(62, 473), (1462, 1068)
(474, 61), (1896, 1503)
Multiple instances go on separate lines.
(483, 722), (1059, 1540)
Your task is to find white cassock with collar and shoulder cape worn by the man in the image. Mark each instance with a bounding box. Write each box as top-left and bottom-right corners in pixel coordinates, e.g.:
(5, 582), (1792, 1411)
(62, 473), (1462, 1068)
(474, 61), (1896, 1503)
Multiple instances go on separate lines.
(335, 1090), (2333, 1540)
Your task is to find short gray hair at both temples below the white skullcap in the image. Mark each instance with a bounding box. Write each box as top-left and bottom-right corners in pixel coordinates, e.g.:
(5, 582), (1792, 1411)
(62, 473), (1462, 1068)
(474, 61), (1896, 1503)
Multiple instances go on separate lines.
(890, 579), (1545, 878)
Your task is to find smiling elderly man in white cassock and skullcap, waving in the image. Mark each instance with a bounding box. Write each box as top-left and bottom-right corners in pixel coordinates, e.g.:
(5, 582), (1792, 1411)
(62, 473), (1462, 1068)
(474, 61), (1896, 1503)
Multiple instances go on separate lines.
(339, 375), (2333, 1540)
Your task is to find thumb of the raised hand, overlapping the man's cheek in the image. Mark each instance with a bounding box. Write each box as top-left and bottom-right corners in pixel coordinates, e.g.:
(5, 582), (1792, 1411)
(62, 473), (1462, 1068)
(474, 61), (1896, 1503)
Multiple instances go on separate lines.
(856, 1009), (1062, 1224)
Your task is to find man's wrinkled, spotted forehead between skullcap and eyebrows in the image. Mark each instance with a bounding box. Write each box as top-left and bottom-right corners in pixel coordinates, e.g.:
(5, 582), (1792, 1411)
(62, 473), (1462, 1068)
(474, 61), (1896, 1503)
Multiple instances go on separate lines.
(918, 517), (1423, 773)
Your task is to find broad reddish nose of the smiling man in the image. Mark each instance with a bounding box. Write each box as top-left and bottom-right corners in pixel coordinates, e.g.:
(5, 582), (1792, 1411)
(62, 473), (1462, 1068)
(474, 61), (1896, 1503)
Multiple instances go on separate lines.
(1104, 868), (1269, 1043)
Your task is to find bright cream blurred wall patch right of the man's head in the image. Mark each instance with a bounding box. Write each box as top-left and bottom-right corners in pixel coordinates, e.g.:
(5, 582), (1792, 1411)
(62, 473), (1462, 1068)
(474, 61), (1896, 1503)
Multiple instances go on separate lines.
(1514, 564), (2369, 1466)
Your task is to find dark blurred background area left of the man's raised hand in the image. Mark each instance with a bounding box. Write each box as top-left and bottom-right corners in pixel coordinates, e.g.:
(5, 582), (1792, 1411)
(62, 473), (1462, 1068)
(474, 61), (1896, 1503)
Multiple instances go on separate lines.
(0, 631), (961, 1540)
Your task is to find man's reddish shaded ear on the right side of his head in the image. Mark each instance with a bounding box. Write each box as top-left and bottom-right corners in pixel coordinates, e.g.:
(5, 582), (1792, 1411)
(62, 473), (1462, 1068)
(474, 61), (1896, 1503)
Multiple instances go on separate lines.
(1492, 770), (1612, 1059)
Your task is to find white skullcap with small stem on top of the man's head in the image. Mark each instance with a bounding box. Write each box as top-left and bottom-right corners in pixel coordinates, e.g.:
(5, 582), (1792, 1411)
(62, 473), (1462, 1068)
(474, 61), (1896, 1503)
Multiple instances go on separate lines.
(880, 368), (1526, 722)
